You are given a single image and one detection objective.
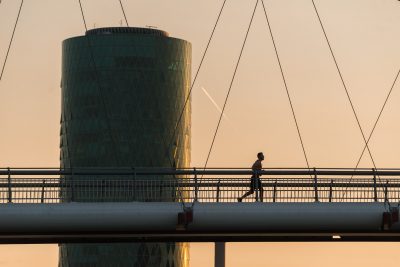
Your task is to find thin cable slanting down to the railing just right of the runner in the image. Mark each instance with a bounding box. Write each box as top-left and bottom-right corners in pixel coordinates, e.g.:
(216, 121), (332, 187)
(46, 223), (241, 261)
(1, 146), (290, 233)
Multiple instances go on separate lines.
(261, 0), (310, 169)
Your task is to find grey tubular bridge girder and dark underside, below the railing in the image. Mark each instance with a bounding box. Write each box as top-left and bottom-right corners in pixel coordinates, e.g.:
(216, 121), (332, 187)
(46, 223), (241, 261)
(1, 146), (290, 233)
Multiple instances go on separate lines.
(0, 202), (400, 244)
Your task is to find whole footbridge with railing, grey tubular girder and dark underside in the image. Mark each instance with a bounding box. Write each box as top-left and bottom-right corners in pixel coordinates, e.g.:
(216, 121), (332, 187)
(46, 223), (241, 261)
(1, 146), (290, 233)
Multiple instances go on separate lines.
(0, 168), (400, 243)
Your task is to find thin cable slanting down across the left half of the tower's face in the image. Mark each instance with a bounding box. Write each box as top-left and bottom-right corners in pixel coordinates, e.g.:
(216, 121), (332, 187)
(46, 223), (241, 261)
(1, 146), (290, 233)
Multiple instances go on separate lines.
(78, 0), (121, 164)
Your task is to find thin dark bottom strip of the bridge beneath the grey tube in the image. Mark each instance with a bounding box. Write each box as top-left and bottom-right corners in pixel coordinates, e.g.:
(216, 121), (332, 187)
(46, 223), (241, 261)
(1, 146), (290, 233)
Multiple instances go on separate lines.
(0, 232), (400, 244)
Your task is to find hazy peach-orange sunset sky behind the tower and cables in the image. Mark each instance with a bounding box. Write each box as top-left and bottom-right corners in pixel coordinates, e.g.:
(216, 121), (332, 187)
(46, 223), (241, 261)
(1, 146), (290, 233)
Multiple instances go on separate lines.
(0, 0), (400, 267)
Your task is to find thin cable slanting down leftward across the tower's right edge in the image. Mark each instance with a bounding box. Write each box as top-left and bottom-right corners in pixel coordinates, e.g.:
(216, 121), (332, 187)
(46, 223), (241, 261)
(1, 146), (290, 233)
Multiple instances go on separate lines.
(166, 0), (227, 167)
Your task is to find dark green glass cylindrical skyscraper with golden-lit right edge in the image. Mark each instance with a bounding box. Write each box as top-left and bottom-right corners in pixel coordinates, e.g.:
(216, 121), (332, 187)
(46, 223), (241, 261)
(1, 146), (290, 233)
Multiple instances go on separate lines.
(60, 27), (191, 267)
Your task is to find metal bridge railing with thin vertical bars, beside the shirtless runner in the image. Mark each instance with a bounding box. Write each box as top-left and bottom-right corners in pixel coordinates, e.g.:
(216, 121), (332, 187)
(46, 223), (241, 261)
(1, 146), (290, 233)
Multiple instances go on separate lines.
(0, 168), (400, 203)
